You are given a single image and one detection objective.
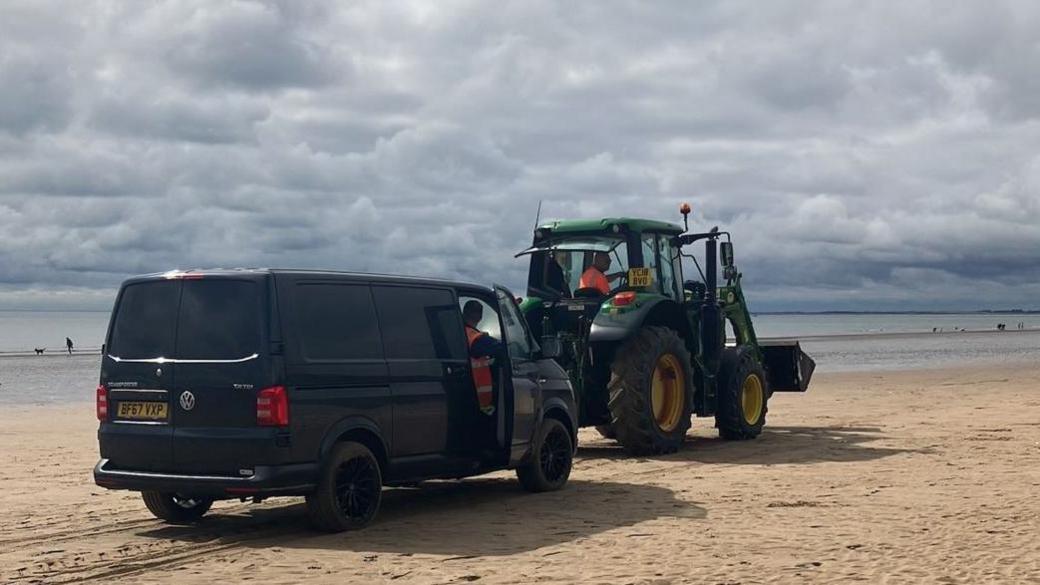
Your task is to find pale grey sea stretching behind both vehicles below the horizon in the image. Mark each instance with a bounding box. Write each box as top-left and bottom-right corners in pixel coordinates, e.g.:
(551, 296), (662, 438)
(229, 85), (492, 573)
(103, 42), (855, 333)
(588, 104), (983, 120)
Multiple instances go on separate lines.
(0, 311), (1040, 404)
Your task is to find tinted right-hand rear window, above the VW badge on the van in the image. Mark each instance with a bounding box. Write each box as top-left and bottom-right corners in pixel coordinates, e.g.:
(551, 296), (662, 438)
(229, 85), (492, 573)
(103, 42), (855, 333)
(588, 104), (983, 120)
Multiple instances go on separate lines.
(177, 279), (261, 359)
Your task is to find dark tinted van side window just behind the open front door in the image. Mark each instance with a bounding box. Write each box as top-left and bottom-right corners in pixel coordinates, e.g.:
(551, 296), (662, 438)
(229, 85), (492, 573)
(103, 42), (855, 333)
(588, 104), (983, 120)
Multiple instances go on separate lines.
(372, 286), (466, 360)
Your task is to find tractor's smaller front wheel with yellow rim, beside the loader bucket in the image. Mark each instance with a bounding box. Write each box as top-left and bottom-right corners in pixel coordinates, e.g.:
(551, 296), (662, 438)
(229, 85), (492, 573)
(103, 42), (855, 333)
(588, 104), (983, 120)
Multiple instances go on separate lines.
(716, 347), (770, 440)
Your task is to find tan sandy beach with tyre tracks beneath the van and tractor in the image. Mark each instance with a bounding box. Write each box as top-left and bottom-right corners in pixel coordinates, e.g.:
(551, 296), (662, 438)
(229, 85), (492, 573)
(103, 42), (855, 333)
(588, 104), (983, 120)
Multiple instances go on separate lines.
(0, 365), (1040, 585)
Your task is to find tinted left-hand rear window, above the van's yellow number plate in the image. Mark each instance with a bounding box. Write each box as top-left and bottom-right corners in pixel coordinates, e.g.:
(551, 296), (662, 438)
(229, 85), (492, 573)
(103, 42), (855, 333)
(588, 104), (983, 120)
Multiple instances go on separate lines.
(108, 280), (181, 359)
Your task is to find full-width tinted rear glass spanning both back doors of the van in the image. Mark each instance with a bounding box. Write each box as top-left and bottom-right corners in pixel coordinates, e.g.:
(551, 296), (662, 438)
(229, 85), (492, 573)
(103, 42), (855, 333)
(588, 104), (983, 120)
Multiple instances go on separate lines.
(108, 279), (261, 360)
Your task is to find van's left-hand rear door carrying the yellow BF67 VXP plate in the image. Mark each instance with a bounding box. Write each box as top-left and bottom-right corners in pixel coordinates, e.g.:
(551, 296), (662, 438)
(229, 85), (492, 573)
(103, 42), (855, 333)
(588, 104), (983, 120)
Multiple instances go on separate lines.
(98, 280), (181, 472)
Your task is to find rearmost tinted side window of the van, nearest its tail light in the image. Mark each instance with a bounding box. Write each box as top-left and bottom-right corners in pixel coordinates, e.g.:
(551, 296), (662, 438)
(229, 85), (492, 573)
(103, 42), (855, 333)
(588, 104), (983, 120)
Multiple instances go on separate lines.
(292, 283), (383, 361)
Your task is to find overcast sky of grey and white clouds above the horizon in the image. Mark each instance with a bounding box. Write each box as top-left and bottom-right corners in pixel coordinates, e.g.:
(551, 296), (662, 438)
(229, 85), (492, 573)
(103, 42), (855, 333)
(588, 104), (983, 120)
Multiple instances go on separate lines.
(0, 0), (1040, 310)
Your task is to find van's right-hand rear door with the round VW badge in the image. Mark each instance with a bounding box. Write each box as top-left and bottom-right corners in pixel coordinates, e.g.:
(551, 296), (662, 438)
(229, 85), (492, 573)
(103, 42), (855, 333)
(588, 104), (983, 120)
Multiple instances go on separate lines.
(171, 275), (276, 475)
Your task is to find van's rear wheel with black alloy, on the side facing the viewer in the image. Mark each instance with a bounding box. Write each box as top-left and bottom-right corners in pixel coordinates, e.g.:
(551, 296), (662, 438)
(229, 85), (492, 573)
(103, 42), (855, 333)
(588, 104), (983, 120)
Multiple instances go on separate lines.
(307, 441), (383, 532)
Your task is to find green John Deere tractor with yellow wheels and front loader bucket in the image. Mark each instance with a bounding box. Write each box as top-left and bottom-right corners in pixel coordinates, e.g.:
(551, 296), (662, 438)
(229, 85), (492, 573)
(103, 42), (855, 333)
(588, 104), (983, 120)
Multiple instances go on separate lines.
(517, 204), (815, 455)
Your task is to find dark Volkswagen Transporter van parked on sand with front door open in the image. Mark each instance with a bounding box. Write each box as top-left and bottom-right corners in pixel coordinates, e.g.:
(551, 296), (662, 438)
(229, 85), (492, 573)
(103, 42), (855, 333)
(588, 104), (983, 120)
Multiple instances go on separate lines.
(94, 270), (577, 531)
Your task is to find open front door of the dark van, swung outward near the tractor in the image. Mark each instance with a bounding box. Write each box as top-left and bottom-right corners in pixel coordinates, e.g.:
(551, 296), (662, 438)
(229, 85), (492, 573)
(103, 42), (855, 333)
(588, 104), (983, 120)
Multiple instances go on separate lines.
(495, 285), (542, 465)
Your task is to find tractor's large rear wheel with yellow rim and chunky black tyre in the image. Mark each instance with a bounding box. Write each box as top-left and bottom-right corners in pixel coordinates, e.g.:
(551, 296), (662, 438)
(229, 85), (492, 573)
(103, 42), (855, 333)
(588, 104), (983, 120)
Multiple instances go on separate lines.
(607, 327), (694, 456)
